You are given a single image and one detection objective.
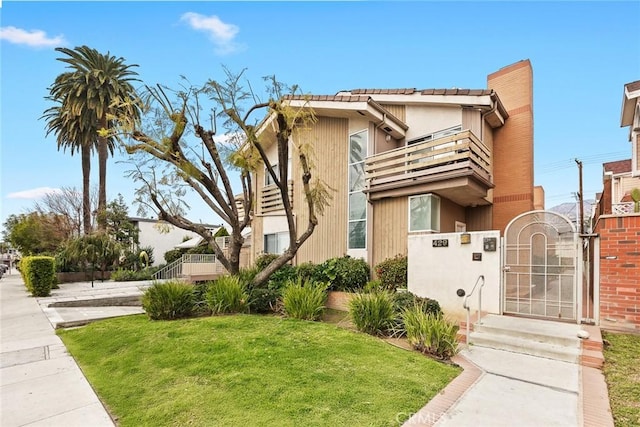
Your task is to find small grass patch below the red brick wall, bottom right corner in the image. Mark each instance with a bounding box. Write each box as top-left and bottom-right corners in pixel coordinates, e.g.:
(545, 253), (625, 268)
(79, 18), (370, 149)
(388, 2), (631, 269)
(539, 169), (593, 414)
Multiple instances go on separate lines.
(603, 332), (640, 427)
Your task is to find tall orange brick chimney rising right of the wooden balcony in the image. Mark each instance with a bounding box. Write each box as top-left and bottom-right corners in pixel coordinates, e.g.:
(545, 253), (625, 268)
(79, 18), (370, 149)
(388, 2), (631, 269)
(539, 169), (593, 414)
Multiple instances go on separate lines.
(487, 60), (534, 232)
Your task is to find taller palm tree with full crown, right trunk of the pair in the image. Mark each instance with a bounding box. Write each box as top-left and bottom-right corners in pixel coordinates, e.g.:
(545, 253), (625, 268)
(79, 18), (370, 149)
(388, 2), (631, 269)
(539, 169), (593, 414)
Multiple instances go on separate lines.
(43, 46), (141, 229)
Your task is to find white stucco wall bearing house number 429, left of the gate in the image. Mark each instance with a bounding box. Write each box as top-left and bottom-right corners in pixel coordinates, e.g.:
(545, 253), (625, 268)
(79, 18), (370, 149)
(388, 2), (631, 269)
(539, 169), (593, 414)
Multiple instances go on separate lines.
(408, 231), (501, 319)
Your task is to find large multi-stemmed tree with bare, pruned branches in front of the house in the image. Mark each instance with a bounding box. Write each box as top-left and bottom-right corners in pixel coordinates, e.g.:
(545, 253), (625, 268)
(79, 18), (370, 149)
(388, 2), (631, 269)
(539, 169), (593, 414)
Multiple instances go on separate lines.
(121, 70), (330, 284)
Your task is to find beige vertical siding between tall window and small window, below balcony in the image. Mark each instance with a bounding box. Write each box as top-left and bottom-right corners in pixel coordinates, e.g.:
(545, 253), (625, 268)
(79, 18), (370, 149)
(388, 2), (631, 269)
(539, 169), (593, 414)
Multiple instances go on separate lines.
(370, 197), (409, 267)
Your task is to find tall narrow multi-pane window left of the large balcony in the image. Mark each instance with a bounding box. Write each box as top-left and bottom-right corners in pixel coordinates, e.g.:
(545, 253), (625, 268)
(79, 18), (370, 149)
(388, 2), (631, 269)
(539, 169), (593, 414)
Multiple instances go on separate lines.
(348, 130), (368, 249)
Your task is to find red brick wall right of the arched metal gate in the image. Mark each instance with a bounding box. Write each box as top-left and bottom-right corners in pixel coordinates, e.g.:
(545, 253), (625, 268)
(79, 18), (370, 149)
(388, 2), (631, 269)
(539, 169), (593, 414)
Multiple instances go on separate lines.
(595, 214), (640, 331)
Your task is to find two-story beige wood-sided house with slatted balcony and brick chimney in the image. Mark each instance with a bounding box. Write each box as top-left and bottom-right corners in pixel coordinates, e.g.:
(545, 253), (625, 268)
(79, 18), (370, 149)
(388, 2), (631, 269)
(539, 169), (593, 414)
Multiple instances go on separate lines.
(252, 60), (544, 266)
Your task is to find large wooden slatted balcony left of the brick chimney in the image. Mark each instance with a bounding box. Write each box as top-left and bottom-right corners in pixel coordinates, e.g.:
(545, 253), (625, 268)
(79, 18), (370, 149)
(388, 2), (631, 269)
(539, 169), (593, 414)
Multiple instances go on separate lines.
(365, 130), (494, 206)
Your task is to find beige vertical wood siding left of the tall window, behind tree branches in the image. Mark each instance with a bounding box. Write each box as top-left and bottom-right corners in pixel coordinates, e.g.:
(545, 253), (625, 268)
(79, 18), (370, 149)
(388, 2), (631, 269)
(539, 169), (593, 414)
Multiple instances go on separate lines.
(292, 117), (349, 264)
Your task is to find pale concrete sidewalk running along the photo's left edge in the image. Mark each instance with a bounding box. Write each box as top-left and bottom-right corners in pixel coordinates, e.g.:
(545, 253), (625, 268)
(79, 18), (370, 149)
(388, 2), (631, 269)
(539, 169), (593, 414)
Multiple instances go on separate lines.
(0, 270), (115, 427)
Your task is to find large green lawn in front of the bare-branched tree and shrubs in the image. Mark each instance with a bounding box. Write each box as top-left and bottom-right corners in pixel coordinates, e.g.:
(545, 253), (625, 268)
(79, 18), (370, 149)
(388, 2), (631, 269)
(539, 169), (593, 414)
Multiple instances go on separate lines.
(59, 315), (460, 426)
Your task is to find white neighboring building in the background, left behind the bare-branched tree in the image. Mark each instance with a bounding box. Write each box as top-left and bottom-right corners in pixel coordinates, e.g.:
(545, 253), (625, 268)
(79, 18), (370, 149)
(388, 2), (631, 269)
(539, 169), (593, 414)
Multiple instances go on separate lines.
(129, 218), (221, 265)
